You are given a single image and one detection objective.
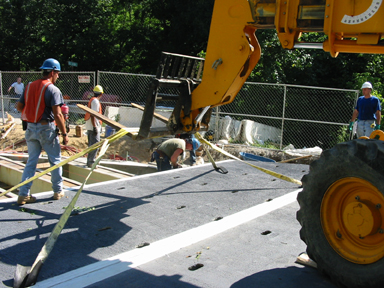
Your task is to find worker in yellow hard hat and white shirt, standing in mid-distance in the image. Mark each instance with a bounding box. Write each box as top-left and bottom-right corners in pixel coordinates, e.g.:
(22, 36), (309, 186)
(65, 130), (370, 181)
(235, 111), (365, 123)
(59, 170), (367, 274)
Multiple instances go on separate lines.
(84, 85), (104, 168)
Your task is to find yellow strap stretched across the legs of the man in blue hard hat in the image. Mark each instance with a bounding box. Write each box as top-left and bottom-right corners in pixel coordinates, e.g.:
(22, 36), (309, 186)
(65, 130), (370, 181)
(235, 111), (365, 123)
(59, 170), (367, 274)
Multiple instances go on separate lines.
(0, 128), (138, 197)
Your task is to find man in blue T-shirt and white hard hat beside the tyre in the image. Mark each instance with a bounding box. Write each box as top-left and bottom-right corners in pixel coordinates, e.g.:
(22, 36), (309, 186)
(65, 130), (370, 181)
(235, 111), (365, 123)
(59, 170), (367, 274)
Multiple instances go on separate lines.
(349, 82), (381, 138)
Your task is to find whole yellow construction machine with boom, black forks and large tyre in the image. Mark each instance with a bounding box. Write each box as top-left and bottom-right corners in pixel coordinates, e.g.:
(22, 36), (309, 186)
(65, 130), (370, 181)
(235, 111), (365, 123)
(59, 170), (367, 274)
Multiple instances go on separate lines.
(139, 0), (384, 288)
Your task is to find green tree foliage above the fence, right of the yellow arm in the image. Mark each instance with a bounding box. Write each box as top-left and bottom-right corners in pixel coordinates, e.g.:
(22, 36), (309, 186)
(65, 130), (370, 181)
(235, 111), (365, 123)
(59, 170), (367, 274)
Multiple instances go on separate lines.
(250, 30), (384, 95)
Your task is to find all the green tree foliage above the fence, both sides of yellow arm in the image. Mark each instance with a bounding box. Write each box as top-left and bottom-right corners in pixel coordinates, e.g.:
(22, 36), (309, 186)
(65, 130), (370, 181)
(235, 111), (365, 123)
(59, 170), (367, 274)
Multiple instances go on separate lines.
(0, 0), (384, 96)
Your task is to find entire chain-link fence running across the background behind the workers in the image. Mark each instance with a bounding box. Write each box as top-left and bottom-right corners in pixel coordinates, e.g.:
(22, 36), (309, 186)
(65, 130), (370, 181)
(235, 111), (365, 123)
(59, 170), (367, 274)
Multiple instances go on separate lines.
(0, 71), (358, 149)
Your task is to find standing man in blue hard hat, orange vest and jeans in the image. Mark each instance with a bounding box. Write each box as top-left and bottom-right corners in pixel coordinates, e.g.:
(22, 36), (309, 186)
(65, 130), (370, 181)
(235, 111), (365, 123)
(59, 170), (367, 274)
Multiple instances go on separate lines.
(16, 58), (69, 205)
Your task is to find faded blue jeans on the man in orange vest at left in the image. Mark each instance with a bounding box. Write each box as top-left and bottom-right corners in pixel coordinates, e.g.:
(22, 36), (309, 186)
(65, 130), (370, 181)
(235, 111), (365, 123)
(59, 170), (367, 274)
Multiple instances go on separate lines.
(19, 122), (63, 196)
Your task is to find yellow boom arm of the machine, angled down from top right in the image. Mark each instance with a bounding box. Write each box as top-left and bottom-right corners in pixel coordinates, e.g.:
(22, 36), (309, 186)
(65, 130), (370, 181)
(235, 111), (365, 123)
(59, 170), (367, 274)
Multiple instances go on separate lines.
(141, 0), (384, 137)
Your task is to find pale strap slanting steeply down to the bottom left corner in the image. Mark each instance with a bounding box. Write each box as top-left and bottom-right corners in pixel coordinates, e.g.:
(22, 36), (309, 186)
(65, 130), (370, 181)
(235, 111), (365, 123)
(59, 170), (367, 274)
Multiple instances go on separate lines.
(13, 139), (109, 288)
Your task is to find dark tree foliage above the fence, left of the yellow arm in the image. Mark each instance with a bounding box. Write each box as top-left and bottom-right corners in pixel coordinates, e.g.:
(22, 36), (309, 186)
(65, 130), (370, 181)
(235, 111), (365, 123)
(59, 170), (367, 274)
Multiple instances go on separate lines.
(0, 0), (213, 73)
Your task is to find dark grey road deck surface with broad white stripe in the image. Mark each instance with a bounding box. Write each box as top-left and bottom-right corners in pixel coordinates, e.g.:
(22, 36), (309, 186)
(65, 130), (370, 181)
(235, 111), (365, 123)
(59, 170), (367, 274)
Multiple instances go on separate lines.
(0, 160), (335, 288)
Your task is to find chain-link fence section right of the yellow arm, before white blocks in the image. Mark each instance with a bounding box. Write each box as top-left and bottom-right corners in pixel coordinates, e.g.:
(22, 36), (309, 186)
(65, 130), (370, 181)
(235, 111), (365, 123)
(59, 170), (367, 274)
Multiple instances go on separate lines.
(214, 82), (359, 149)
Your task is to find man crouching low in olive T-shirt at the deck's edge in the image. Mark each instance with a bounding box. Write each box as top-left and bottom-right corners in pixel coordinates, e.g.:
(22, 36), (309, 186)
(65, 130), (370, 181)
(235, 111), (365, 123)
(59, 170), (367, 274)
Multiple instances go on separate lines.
(151, 138), (200, 171)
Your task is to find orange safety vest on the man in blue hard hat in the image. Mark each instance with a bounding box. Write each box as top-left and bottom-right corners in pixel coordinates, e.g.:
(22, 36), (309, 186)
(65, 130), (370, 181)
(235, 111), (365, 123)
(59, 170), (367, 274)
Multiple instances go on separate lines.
(21, 79), (52, 123)
